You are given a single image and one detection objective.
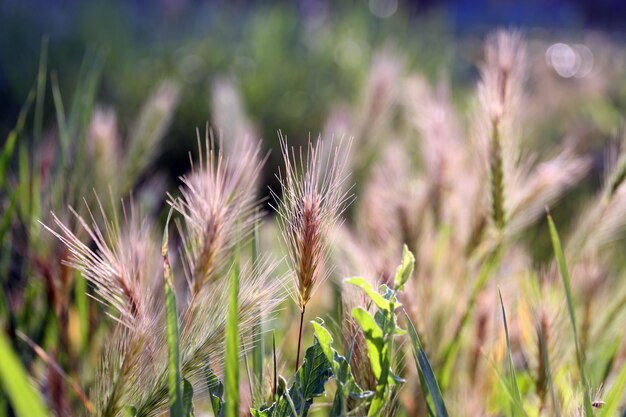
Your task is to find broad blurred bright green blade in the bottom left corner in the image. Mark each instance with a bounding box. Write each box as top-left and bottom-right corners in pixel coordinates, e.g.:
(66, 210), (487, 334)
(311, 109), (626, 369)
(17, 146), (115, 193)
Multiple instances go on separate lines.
(0, 332), (49, 417)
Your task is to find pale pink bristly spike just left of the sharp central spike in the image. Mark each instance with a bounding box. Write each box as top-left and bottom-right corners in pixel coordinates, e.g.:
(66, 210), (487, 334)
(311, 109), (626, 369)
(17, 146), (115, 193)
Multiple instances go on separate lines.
(169, 127), (264, 296)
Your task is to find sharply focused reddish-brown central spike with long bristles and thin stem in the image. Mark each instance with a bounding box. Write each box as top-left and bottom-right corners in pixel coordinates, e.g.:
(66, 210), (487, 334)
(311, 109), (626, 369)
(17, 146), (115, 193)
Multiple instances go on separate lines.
(274, 135), (351, 369)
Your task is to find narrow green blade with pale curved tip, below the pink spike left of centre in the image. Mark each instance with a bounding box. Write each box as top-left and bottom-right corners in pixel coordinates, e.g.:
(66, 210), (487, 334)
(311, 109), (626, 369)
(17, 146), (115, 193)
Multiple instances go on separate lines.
(161, 209), (185, 417)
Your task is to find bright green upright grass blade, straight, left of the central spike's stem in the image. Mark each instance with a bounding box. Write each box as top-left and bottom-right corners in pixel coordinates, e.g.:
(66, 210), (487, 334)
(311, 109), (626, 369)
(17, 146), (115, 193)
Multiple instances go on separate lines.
(224, 251), (239, 417)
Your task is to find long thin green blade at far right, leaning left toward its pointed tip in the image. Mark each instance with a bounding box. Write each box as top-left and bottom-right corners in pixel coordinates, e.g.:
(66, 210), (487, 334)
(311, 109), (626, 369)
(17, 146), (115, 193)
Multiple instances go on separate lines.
(548, 213), (593, 416)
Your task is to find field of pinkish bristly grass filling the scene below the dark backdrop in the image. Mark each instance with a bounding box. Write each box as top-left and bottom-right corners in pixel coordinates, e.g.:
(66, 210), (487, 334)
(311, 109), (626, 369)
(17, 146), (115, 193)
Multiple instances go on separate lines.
(0, 9), (626, 417)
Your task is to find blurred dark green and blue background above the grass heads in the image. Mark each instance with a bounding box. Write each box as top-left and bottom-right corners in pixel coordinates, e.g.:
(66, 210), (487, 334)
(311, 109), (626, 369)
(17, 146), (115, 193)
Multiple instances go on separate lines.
(0, 0), (625, 188)
